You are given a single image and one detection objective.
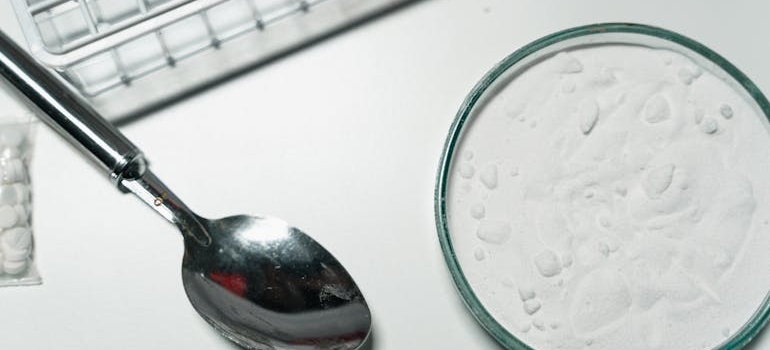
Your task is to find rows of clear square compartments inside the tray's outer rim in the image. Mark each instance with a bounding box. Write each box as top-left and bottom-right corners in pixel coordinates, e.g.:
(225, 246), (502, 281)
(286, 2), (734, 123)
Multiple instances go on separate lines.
(21, 0), (328, 96)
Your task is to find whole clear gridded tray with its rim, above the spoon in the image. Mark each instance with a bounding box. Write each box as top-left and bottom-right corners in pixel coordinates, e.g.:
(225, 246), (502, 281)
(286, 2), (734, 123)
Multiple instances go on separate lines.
(12, 0), (413, 119)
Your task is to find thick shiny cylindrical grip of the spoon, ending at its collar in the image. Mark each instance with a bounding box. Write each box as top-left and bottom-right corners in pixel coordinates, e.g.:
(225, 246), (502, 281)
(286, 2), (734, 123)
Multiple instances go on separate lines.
(0, 31), (147, 191)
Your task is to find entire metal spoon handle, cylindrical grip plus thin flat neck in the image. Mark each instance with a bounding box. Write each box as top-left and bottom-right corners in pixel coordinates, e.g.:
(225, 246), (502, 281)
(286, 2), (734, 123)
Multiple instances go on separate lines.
(0, 30), (211, 246)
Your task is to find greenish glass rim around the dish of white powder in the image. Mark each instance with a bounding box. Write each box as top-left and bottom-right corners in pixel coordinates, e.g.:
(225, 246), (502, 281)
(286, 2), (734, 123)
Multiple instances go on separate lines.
(434, 23), (770, 350)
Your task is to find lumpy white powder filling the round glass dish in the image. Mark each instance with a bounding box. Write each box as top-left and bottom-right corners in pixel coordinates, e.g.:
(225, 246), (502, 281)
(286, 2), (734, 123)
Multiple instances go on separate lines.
(446, 44), (770, 350)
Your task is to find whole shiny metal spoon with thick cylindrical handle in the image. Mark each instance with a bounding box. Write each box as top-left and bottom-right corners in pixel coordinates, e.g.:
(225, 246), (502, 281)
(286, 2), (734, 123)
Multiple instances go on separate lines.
(0, 32), (371, 350)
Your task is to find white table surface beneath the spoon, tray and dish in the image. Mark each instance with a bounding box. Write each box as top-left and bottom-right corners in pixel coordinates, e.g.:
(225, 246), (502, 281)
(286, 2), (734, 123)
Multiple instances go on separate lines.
(0, 0), (770, 350)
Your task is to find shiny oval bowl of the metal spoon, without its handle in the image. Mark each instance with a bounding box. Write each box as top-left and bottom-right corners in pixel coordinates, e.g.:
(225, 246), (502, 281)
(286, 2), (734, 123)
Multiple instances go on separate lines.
(182, 215), (371, 350)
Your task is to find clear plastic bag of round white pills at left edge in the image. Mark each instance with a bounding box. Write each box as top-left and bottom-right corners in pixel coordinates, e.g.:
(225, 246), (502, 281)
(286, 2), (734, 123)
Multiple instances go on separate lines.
(0, 89), (41, 287)
